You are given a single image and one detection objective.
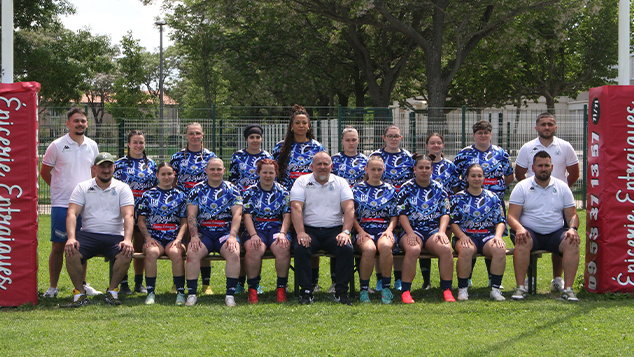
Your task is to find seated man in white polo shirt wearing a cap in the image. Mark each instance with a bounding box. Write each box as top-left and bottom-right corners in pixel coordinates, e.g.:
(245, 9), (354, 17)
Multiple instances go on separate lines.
(64, 153), (134, 307)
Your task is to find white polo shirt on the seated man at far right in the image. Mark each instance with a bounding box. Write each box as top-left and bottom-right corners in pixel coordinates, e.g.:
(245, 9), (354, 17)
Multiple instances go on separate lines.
(509, 176), (575, 234)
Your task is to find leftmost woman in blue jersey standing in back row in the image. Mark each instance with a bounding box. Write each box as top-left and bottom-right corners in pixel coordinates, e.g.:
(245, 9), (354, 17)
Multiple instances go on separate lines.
(112, 130), (157, 294)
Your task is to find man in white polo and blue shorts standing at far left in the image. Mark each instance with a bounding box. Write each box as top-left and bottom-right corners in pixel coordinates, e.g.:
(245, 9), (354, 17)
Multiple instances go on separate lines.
(40, 107), (101, 297)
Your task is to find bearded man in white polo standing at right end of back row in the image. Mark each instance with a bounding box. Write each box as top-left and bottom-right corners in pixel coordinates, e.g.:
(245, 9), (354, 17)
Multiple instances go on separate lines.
(515, 113), (579, 292)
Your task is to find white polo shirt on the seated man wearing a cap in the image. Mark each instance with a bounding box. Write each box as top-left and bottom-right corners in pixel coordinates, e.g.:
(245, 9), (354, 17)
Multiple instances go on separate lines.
(70, 178), (134, 236)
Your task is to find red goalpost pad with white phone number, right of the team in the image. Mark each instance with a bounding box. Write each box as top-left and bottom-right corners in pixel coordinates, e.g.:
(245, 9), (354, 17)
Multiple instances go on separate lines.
(585, 86), (634, 293)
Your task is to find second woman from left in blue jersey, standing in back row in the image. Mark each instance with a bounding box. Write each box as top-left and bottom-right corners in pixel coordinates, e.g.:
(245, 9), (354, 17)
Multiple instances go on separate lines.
(170, 122), (216, 295)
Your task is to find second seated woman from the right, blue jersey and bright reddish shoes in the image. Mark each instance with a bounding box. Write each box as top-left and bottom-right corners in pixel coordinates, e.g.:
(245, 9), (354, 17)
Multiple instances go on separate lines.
(397, 155), (456, 304)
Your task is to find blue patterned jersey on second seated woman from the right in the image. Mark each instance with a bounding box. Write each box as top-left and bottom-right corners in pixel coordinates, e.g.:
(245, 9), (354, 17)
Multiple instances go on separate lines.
(396, 179), (451, 247)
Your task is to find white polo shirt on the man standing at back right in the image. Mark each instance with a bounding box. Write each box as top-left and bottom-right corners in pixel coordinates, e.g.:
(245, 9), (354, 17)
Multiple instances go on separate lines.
(515, 136), (579, 182)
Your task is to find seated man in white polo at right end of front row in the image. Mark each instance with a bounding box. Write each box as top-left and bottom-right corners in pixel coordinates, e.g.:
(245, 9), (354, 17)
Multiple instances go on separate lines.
(507, 151), (580, 301)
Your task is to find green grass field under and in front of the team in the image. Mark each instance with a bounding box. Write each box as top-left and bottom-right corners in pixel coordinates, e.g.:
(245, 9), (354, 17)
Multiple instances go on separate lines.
(0, 212), (634, 356)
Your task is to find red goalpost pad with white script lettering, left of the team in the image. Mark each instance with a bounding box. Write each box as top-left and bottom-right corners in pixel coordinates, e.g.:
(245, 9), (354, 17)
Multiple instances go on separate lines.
(0, 82), (40, 306)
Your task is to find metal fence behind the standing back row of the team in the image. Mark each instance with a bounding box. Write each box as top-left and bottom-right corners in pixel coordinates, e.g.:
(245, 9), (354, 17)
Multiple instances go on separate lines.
(38, 105), (587, 213)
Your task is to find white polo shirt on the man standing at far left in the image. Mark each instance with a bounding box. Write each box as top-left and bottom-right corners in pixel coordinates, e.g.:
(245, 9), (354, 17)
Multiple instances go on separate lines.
(42, 134), (99, 208)
